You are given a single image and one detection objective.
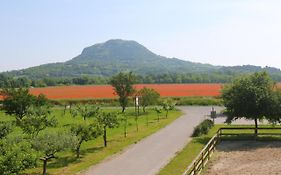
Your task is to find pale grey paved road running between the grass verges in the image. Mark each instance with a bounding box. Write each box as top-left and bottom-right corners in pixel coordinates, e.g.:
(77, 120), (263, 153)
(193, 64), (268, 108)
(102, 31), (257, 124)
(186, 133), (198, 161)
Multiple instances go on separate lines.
(83, 106), (221, 175)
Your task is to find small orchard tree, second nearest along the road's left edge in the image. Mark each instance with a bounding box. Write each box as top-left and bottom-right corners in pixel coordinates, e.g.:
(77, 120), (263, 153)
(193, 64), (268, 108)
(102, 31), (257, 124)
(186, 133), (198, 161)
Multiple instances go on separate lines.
(71, 123), (101, 158)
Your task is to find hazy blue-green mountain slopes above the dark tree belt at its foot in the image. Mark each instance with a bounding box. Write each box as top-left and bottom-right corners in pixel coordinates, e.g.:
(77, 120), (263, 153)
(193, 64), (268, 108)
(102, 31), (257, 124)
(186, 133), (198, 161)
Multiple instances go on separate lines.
(2, 39), (281, 79)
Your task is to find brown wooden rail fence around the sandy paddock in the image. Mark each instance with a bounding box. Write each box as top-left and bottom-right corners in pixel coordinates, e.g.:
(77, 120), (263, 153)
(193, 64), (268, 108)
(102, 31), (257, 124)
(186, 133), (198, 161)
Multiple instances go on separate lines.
(182, 127), (281, 175)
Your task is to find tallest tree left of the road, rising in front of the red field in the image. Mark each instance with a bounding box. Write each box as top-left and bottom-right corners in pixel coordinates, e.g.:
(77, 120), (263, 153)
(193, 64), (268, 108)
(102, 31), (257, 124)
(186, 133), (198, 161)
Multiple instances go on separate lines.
(110, 72), (136, 112)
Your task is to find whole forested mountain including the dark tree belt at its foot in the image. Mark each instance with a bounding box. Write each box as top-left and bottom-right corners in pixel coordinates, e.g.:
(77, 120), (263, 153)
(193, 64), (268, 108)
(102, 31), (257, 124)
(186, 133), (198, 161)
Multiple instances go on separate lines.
(0, 39), (281, 87)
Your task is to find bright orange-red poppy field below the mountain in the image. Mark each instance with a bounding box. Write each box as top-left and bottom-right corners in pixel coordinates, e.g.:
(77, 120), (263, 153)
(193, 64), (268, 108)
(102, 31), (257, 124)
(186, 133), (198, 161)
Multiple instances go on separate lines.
(30, 84), (222, 99)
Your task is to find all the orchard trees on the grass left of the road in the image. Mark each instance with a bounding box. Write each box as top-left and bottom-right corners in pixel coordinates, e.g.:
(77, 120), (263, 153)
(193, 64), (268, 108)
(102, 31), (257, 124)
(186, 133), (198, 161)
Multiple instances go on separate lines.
(0, 73), (174, 174)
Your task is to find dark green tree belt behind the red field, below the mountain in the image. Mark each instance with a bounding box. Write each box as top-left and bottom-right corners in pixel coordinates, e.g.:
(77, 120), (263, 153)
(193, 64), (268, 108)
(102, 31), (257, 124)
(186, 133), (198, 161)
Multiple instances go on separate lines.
(3, 72), (281, 88)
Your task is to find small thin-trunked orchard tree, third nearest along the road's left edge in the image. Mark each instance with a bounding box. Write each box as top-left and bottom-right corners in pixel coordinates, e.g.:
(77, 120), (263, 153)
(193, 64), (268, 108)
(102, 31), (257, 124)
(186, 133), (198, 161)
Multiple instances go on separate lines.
(97, 112), (119, 147)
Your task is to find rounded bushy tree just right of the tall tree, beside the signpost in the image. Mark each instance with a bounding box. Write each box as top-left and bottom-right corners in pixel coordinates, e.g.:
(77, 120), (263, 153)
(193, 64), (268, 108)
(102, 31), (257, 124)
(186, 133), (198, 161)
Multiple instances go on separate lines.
(138, 87), (160, 112)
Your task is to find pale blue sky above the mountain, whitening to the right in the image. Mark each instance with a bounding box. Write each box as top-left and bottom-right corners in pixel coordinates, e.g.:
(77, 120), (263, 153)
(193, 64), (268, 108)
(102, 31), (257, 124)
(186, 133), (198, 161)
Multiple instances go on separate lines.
(0, 0), (281, 72)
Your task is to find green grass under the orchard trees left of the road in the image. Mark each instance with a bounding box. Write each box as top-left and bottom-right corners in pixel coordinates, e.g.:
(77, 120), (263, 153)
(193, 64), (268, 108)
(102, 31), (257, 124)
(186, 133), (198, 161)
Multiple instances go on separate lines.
(0, 108), (181, 175)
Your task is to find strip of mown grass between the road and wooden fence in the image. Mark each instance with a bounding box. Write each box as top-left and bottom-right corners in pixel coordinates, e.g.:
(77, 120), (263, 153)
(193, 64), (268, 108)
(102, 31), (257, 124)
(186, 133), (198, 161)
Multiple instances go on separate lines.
(157, 125), (281, 175)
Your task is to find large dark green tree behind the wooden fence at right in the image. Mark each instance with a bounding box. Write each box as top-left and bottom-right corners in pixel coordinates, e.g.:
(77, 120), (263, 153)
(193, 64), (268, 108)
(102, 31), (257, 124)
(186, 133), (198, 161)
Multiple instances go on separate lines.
(222, 72), (274, 134)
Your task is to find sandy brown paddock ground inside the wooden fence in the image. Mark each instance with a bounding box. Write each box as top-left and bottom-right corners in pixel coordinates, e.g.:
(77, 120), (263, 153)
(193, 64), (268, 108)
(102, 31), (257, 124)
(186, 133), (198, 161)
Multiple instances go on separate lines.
(203, 141), (281, 175)
